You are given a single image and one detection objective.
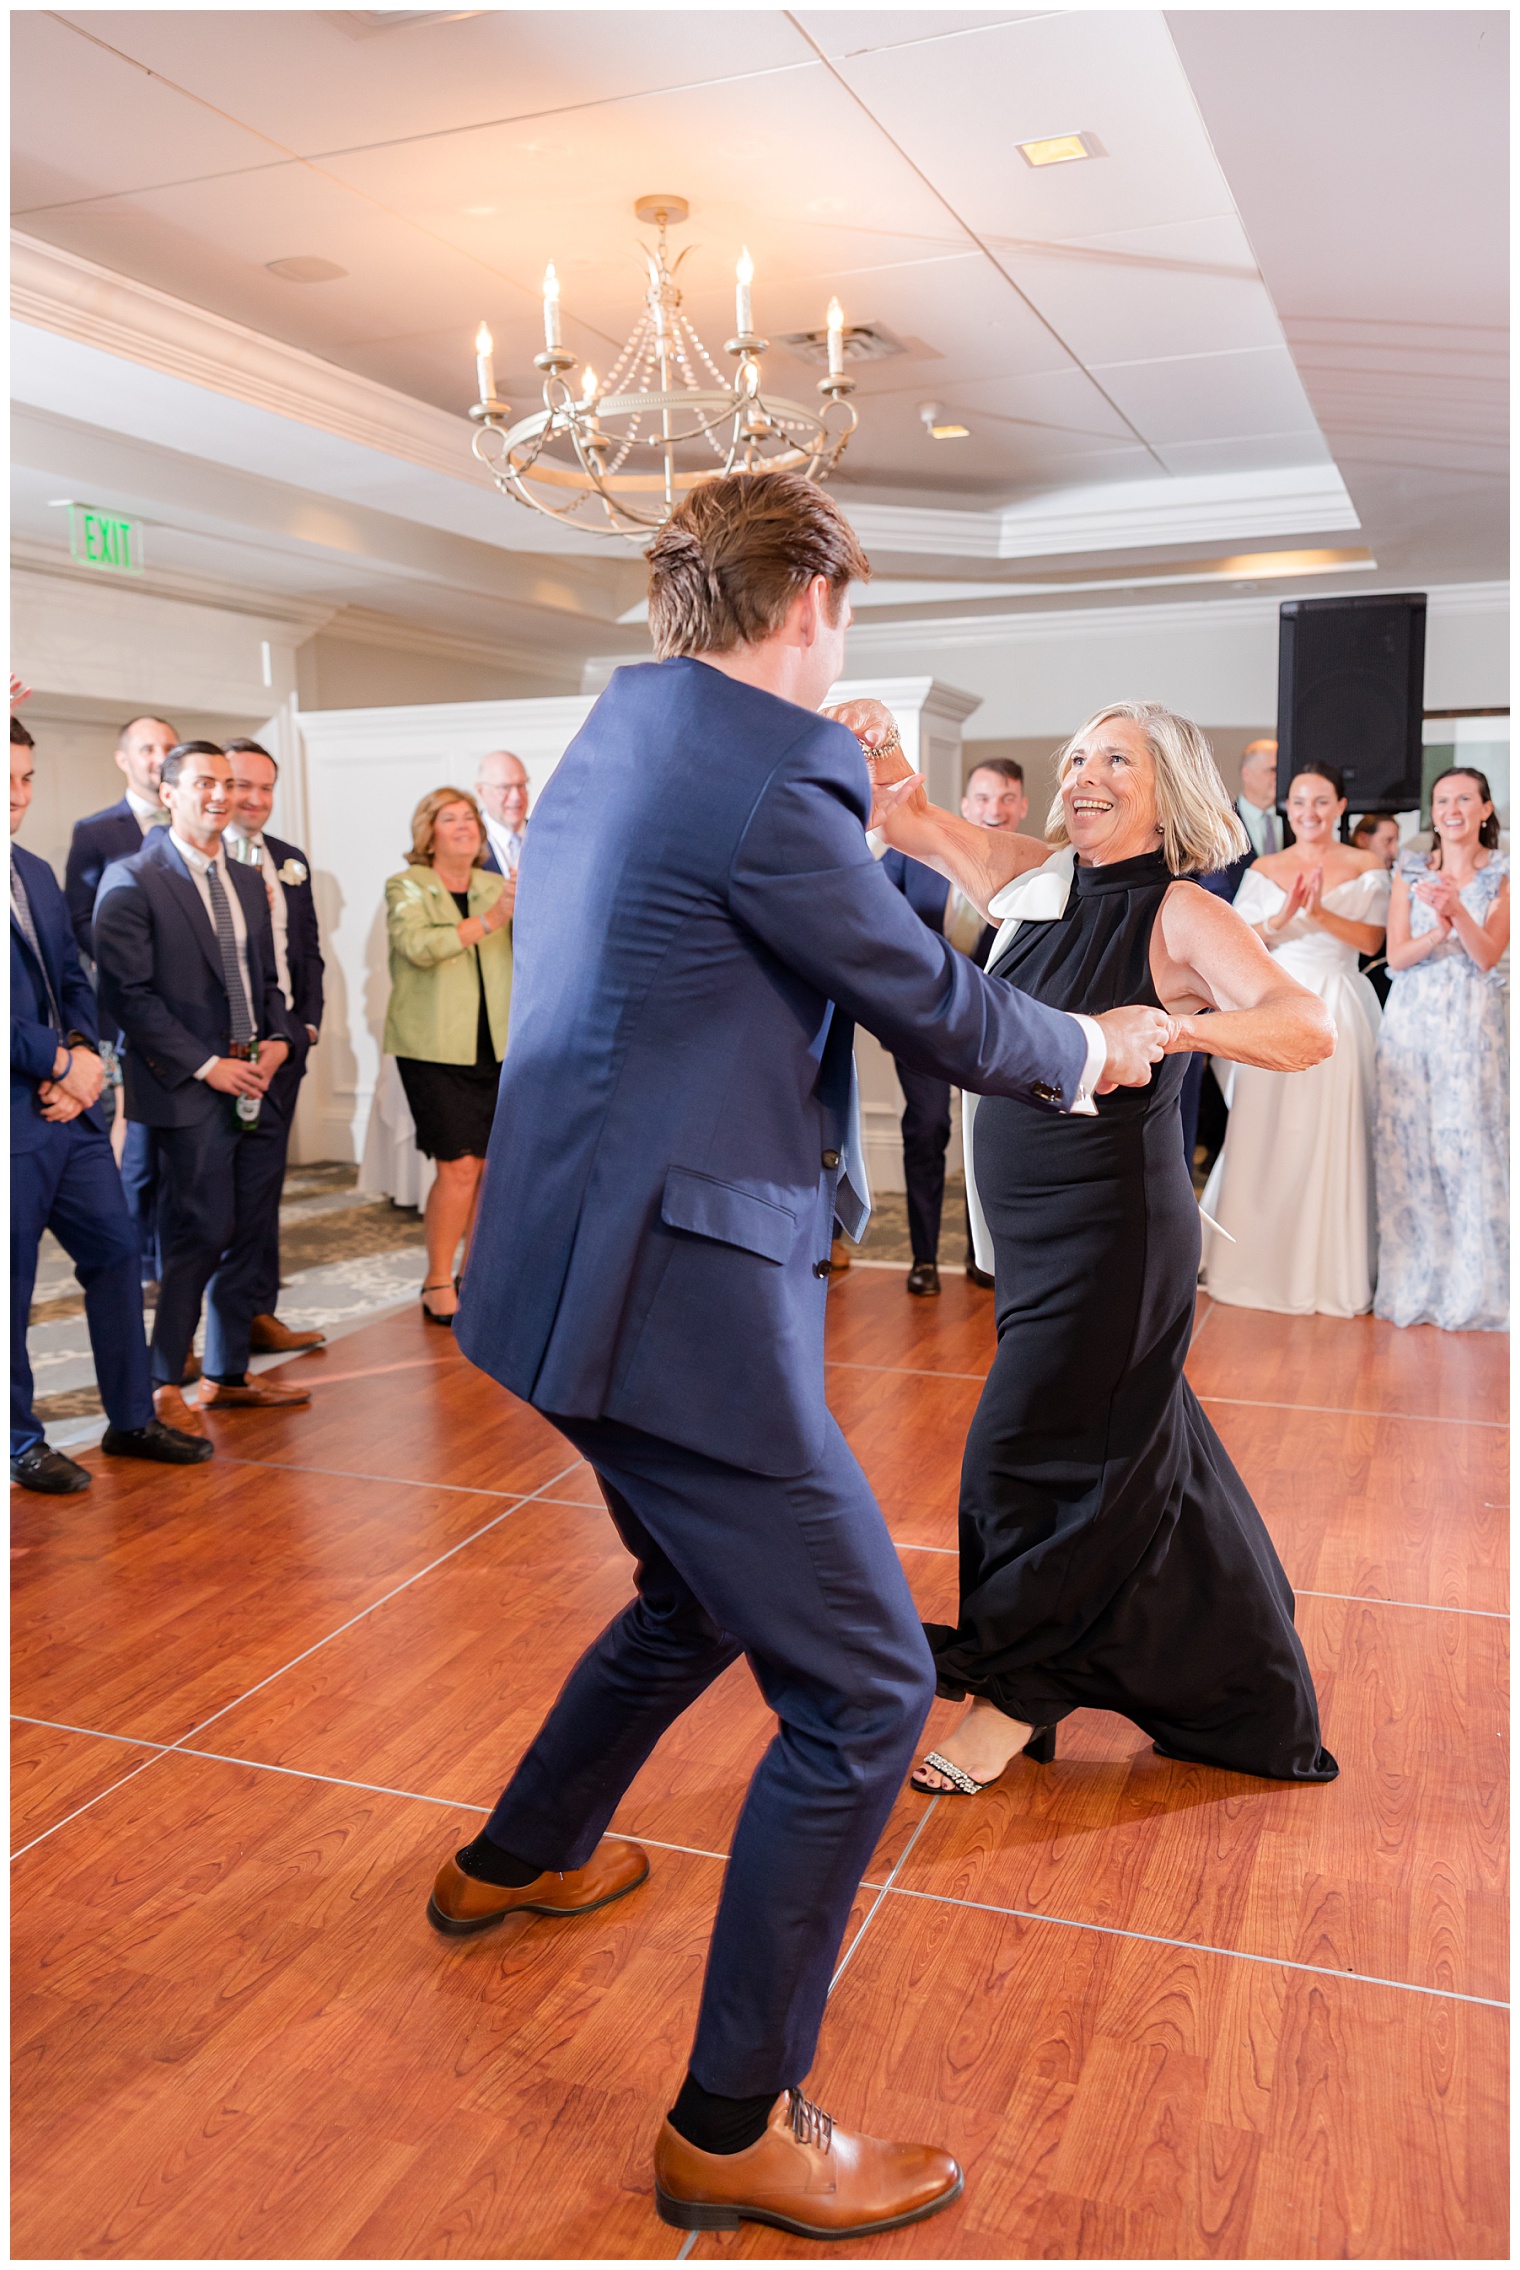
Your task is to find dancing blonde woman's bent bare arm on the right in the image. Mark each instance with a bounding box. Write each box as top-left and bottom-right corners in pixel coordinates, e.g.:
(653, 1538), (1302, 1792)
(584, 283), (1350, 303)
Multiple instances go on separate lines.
(1150, 883), (1336, 1071)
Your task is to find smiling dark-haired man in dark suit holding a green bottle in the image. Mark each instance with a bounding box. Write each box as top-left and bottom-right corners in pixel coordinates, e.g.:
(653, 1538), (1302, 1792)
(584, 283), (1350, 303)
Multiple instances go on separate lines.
(95, 740), (311, 1435)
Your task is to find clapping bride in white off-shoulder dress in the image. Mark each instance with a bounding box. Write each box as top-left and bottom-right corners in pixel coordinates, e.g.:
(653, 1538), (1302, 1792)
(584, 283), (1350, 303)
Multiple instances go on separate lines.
(1202, 772), (1391, 1317)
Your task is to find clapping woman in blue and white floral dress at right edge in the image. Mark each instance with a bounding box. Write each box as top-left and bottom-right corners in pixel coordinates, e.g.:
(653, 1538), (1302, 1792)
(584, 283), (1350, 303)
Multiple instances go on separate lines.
(1375, 767), (1509, 1332)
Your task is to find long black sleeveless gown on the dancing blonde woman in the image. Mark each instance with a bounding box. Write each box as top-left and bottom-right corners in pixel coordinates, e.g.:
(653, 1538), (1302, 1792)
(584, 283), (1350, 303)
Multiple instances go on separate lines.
(926, 854), (1339, 1782)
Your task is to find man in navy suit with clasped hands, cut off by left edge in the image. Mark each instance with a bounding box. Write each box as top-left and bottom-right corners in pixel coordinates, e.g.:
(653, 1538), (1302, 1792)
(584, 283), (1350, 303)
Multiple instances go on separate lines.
(11, 717), (211, 1496)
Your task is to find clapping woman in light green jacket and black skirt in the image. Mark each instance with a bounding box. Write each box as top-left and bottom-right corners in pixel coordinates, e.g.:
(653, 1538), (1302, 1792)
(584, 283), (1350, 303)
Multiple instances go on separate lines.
(383, 788), (517, 1326)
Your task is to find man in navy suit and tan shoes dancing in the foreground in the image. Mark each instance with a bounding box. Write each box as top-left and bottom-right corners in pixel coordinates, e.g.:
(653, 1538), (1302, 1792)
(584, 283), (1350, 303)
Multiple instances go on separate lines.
(440, 472), (1171, 2236)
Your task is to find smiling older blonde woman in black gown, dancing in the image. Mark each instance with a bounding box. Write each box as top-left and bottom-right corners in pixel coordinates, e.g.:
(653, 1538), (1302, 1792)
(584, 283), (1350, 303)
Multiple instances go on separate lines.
(871, 701), (1336, 1793)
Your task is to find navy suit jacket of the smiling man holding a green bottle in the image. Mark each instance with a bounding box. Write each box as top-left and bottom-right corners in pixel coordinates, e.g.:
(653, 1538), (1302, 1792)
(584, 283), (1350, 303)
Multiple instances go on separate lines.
(95, 829), (306, 1128)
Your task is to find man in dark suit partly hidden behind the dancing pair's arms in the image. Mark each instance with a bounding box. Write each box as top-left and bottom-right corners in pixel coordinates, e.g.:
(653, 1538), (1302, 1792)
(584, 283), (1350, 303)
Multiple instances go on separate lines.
(880, 756), (1030, 1296)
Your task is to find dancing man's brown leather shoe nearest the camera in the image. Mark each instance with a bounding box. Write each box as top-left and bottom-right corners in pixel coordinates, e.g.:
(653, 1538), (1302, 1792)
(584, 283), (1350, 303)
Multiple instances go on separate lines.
(653, 2088), (964, 2238)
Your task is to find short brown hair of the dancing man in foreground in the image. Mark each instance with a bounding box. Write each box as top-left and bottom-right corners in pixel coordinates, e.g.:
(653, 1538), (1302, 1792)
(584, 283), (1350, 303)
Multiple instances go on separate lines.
(647, 472), (871, 663)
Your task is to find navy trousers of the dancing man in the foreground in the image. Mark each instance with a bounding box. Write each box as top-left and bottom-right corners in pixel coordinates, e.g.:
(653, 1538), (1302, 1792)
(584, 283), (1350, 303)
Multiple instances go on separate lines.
(485, 1414), (935, 2097)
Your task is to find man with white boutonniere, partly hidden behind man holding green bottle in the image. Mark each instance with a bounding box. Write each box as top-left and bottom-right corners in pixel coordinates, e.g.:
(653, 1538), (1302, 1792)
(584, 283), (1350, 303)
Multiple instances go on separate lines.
(222, 740), (327, 1355)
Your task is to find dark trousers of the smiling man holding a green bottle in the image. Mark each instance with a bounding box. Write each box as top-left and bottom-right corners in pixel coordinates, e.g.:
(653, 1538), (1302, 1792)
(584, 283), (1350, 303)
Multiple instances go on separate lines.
(152, 1090), (290, 1387)
